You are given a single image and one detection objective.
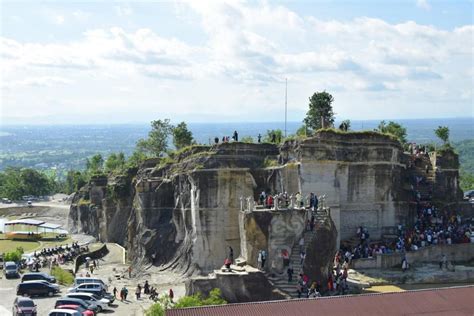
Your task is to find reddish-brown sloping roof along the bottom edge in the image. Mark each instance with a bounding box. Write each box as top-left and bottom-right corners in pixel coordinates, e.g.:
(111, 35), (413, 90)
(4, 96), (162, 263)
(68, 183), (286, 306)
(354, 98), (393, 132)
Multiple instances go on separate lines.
(166, 286), (474, 316)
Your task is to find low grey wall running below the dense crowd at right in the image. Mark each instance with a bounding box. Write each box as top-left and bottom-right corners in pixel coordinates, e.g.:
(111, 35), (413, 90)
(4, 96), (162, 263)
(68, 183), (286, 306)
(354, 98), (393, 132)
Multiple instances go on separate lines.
(352, 243), (474, 269)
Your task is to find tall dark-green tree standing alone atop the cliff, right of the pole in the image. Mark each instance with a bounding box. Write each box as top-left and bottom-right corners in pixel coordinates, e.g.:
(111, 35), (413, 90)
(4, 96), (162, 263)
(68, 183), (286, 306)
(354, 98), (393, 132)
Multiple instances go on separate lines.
(304, 91), (334, 131)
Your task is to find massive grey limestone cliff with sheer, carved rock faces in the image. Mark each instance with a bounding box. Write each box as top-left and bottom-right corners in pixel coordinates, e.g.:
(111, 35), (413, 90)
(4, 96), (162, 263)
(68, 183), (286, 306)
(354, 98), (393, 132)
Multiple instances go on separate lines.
(69, 131), (457, 273)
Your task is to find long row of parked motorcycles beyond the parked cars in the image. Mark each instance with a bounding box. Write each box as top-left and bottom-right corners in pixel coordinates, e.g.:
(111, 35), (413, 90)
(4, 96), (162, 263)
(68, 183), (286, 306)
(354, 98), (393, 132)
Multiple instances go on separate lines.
(24, 242), (89, 272)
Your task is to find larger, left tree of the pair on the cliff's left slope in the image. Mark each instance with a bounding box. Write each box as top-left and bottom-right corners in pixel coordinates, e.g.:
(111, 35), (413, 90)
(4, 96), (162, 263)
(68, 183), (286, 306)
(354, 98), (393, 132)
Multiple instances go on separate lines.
(137, 119), (173, 157)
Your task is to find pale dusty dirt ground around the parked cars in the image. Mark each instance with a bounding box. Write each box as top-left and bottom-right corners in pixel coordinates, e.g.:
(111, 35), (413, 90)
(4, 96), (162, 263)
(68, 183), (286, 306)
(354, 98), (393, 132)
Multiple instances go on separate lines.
(0, 202), (185, 316)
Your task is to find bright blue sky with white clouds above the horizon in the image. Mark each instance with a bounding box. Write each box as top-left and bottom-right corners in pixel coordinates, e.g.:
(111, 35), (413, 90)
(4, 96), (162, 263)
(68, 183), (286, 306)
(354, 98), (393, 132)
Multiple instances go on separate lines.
(0, 0), (474, 124)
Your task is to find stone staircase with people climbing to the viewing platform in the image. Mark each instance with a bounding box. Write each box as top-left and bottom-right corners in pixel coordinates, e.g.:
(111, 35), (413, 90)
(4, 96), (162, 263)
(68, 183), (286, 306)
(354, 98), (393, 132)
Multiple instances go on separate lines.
(267, 210), (328, 298)
